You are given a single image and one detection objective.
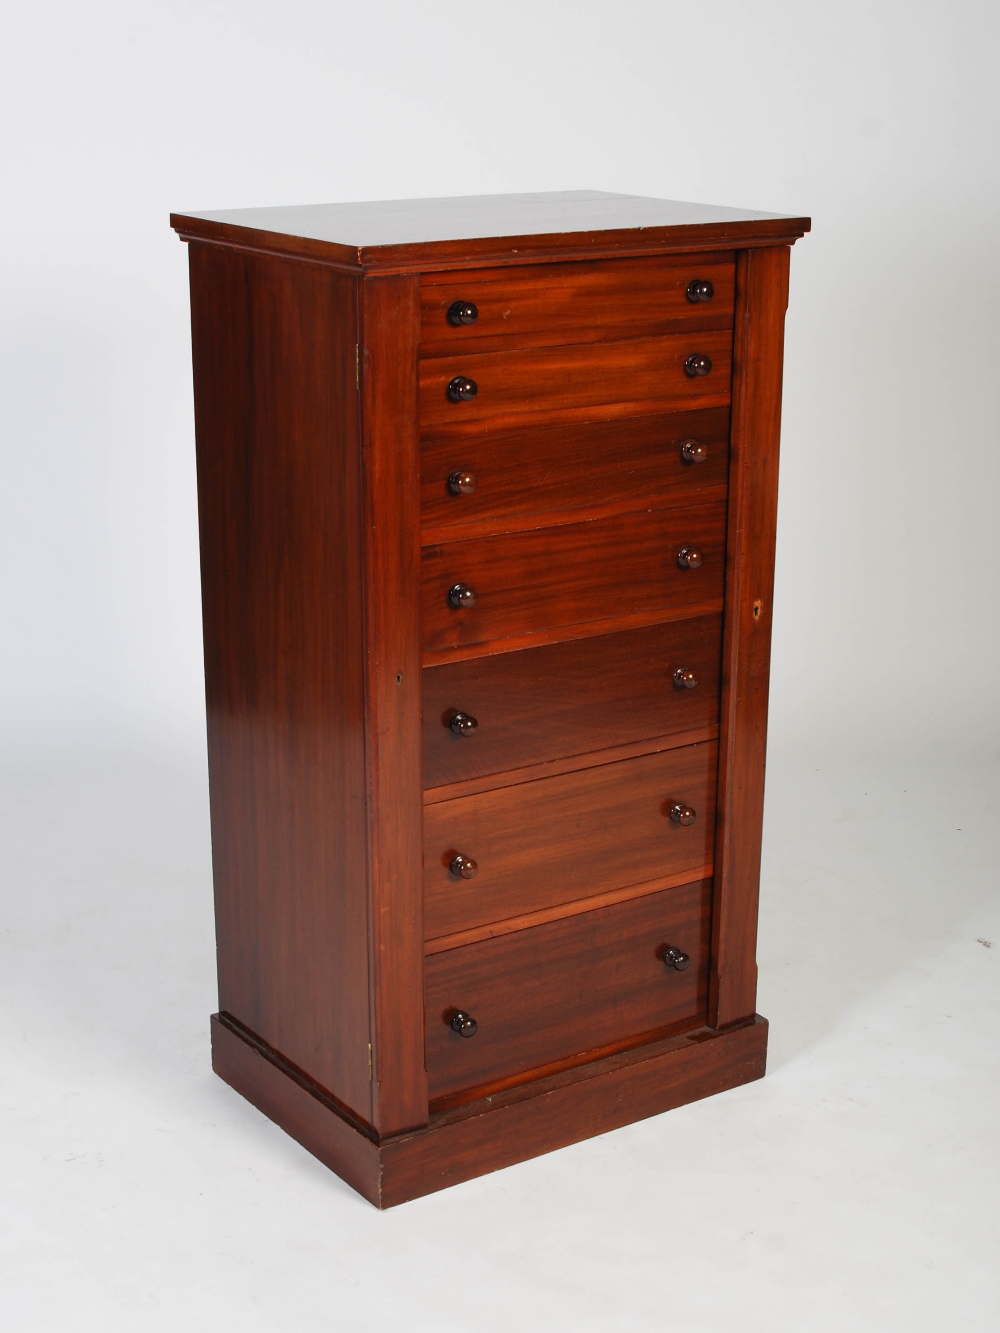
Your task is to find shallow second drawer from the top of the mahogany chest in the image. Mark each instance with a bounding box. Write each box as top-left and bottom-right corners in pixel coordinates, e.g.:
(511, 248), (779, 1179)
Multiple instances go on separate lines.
(420, 331), (732, 429)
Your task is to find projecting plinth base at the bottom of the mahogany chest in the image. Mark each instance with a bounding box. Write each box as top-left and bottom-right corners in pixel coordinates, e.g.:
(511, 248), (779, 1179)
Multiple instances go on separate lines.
(212, 1014), (767, 1208)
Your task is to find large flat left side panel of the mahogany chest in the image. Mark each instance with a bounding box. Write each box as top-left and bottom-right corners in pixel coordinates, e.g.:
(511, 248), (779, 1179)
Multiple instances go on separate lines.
(189, 245), (372, 1121)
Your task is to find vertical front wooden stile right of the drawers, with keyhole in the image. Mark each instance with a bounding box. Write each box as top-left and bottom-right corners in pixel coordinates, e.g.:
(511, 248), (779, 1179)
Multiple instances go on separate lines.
(712, 248), (789, 1026)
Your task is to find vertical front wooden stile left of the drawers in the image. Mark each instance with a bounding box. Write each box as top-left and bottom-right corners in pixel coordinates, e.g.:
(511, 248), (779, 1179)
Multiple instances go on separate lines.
(360, 277), (427, 1134)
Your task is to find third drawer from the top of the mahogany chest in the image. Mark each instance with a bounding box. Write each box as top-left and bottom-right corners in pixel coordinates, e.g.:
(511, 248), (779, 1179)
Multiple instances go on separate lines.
(420, 408), (729, 541)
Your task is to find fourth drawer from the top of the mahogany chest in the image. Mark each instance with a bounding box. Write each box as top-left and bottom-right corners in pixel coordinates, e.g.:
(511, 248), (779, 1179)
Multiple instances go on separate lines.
(421, 501), (725, 651)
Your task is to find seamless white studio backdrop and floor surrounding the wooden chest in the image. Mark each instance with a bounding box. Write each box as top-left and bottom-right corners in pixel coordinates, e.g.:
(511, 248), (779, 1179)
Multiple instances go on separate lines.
(0, 0), (1000, 1333)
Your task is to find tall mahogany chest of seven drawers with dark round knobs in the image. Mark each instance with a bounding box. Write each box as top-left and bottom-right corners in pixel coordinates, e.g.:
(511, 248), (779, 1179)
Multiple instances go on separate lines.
(172, 192), (809, 1206)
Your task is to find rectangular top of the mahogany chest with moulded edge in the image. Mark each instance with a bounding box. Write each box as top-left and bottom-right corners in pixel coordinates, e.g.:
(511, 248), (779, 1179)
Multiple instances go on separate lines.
(171, 189), (809, 272)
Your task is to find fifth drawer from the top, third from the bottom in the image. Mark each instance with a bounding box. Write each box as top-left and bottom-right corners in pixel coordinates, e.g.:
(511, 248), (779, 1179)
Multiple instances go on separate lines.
(424, 615), (723, 788)
